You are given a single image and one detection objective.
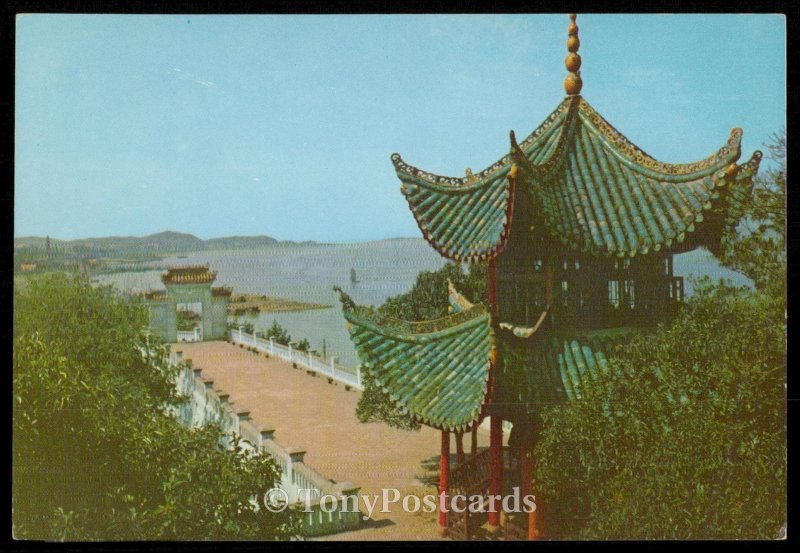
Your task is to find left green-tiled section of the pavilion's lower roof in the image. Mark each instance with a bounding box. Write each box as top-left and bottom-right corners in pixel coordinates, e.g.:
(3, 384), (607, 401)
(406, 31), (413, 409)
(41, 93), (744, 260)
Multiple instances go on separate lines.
(339, 290), (490, 430)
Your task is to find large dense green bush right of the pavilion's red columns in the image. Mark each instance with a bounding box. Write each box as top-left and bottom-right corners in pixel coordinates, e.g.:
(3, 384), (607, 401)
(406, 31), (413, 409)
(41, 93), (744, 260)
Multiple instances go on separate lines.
(534, 281), (786, 539)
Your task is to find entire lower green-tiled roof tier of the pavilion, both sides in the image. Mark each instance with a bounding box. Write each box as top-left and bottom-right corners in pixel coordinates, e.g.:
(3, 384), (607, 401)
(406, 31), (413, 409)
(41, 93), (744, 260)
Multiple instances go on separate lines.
(337, 287), (640, 424)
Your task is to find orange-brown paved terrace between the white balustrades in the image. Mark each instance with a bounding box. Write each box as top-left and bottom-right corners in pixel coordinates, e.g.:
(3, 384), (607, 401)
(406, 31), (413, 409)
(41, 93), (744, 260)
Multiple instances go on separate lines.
(172, 342), (496, 540)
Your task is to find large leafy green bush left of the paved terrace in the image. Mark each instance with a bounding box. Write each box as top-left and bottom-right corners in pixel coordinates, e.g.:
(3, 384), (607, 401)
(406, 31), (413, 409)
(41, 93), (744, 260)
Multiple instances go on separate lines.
(12, 274), (294, 540)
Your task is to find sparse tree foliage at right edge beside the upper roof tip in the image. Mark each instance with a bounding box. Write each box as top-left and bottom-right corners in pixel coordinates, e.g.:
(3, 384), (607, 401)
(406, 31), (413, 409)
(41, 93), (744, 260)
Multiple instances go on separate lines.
(723, 130), (786, 294)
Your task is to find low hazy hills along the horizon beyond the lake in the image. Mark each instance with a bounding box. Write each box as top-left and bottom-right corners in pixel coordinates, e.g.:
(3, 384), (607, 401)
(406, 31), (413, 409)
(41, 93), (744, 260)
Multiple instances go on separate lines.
(14, 230), (318, 257)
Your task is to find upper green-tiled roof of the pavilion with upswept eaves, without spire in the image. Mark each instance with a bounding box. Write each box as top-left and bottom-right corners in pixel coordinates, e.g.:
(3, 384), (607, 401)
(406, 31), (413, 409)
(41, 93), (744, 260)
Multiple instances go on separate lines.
(392, 96), (761, 262)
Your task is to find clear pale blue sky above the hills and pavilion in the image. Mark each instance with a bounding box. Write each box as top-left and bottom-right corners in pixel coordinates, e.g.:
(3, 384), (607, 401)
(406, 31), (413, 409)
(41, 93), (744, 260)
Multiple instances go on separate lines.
(14, 14), (786, 242)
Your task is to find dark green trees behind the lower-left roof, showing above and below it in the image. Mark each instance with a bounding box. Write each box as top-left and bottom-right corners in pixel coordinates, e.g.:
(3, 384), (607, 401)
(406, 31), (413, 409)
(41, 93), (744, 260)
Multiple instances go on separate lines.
(356, 263), (489, 430)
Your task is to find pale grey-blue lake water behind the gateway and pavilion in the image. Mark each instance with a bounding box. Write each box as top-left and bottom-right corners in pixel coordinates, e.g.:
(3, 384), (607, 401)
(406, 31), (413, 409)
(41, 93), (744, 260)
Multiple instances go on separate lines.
(97, 238), (748, 367)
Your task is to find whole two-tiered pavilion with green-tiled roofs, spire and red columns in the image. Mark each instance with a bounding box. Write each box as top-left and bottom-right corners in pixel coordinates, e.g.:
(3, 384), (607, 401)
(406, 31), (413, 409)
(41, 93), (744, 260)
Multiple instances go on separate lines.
(334, 14), (761, 539)
